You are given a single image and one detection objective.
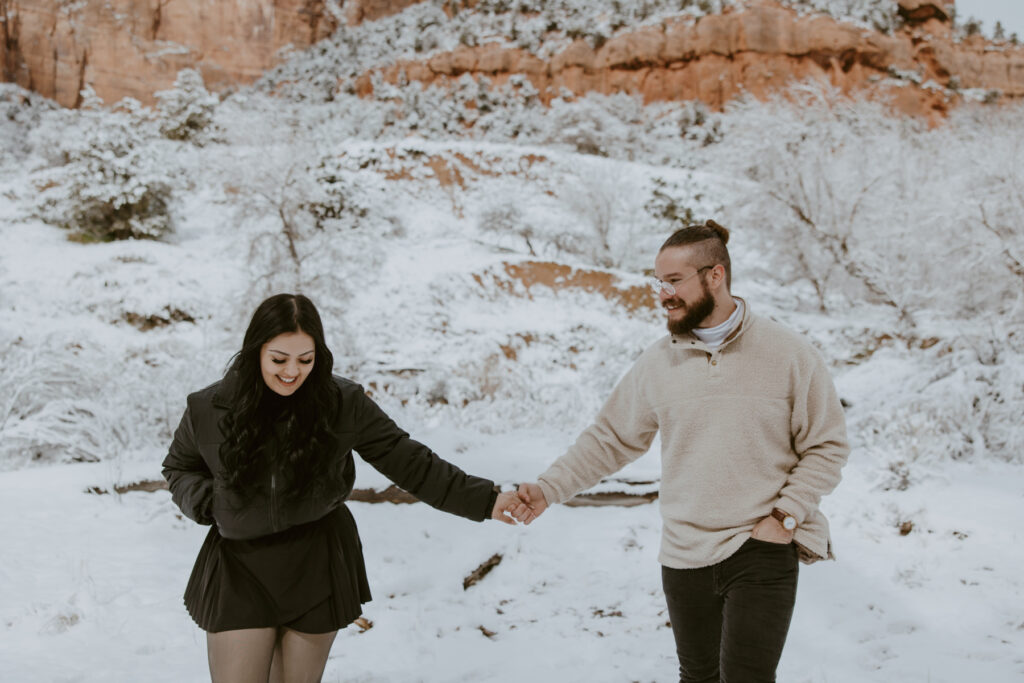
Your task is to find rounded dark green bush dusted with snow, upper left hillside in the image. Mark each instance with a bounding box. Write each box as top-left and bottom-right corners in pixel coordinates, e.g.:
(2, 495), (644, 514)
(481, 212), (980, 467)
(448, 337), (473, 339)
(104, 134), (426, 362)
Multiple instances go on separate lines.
(32, 89), (174, 242)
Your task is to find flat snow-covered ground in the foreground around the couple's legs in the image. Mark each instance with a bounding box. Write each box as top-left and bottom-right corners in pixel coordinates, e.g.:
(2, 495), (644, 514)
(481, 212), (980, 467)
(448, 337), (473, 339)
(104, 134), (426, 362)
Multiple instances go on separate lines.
(0, 440), (1024, 683)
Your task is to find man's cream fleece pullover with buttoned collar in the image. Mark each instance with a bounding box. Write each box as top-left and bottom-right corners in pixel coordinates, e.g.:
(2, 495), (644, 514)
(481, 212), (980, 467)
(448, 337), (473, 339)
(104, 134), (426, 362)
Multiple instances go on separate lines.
(539, 304), (850, 569)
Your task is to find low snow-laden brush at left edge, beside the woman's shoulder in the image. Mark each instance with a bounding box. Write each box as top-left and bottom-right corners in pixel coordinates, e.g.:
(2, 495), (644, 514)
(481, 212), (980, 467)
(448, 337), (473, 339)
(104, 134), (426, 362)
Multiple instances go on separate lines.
(0, 333), (212, 470)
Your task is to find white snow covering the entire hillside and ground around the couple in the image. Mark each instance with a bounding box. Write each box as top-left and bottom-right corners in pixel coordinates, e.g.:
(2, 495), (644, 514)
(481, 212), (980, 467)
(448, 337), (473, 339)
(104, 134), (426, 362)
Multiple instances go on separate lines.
(0, 9), (1024, 683)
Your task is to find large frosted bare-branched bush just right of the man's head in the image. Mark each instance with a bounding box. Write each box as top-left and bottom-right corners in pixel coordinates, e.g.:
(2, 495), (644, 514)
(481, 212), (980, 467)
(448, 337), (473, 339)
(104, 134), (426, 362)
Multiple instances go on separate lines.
(710, 84), (975, 326)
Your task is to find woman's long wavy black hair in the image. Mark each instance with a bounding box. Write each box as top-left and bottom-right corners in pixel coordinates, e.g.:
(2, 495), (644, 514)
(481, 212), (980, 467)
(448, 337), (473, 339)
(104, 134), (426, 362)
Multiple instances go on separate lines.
(220, 294), (340, 498)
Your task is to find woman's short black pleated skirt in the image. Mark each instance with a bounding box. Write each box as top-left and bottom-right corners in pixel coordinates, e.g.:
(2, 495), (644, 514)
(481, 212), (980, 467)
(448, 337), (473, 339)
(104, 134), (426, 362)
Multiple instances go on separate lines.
(184, 505), (371, 633)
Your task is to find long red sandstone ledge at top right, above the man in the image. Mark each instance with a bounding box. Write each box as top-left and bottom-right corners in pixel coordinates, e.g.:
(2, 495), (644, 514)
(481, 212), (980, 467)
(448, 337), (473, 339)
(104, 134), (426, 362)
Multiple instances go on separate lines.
(366, 0), (1024, 120)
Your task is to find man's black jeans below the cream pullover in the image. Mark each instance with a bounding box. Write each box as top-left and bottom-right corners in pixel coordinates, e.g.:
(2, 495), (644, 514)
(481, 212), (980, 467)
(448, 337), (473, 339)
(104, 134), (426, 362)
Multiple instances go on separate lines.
(662, 539), (798, 683)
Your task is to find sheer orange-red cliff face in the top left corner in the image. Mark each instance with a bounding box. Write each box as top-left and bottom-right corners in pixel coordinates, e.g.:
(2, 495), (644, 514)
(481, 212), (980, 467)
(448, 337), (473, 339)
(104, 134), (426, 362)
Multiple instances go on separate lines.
(0, 0), (338, 106)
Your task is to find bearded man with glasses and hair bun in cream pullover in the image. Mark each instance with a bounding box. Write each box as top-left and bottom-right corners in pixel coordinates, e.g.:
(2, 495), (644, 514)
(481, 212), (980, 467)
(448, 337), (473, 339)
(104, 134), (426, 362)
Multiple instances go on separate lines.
(513, 220), (849, 683)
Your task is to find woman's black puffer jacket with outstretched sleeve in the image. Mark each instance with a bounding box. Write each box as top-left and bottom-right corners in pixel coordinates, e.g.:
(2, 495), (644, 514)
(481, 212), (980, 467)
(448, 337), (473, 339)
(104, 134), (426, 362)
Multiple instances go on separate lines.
(163, 376), (495, 539)
